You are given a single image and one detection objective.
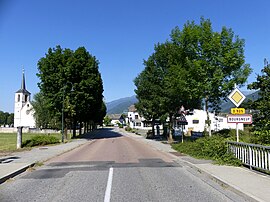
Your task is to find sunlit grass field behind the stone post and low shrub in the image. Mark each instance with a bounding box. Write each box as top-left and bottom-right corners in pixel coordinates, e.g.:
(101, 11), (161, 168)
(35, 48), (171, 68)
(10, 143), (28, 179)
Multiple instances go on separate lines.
(0, 133), (71, 151)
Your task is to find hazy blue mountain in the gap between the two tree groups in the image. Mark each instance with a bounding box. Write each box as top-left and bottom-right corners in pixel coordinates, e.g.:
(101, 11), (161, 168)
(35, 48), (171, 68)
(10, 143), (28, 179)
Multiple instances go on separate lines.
(106, 95), (138, 114)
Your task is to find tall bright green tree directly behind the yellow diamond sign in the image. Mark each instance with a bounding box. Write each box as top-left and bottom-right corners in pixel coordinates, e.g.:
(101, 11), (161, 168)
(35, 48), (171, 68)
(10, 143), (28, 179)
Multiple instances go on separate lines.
(171, 18), (251, 135)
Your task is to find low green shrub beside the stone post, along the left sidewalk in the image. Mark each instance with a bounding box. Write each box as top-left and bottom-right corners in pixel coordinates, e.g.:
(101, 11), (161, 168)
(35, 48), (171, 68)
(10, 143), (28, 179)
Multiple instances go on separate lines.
(22, 135), (59, 147)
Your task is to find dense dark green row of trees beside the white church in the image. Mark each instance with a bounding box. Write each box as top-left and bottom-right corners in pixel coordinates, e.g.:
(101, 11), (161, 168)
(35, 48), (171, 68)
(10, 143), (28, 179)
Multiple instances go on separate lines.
(33, 46), (106, 135)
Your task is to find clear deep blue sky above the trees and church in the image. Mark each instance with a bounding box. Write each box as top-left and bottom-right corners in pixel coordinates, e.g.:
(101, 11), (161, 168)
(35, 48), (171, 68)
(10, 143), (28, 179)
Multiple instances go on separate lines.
(0, 0), (270, 112)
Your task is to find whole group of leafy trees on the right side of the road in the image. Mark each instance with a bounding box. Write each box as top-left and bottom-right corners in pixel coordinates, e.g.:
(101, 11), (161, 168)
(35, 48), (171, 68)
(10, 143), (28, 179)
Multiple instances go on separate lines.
(134, 18), (251, 139)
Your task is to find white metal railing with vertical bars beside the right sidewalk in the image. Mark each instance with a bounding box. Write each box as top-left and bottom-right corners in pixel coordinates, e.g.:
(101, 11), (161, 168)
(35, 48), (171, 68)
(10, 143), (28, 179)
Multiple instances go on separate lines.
(227, 141), (270, 171)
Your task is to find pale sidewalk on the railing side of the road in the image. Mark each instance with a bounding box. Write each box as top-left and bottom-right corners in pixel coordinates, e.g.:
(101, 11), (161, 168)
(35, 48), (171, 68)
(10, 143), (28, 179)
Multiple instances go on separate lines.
(120, 130), (270, 201)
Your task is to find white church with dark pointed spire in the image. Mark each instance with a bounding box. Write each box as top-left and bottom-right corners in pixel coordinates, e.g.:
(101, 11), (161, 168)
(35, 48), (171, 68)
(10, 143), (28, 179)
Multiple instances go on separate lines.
(14, 71), (36, 128)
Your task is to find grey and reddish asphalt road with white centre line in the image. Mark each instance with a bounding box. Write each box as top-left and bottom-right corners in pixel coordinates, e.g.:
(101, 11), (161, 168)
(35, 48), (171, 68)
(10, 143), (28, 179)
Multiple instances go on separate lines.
(0, 129), (248, 202)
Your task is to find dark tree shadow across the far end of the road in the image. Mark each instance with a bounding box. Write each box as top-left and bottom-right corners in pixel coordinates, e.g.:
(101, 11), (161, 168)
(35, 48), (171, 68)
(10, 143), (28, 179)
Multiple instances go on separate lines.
(76, 128), (123, 140)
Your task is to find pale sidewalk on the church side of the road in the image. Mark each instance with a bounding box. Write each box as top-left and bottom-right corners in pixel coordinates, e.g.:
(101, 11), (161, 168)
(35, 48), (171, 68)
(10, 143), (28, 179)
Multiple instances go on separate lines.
(0, 139), (87, 184)
